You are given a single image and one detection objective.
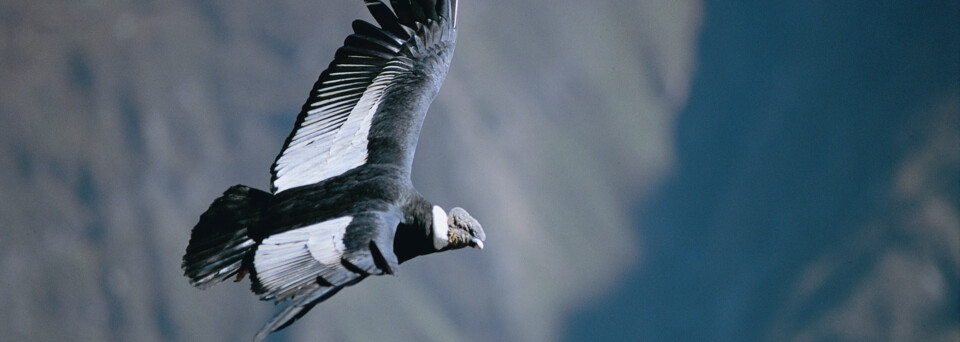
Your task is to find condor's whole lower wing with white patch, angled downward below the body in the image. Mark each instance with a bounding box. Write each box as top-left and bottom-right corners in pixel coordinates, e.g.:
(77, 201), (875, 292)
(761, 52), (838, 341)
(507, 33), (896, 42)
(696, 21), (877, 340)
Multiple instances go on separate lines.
(252, 212), (400, 339)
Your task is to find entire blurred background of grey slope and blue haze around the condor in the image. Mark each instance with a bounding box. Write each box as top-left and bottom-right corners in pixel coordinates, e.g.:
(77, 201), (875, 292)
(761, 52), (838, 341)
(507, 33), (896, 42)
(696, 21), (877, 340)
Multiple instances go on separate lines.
(0, 0), (960, 341)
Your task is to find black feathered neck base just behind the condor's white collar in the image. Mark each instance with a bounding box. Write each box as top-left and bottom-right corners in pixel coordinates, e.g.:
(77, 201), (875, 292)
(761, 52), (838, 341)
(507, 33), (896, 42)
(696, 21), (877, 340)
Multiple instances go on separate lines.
(393, 194), (436, 263)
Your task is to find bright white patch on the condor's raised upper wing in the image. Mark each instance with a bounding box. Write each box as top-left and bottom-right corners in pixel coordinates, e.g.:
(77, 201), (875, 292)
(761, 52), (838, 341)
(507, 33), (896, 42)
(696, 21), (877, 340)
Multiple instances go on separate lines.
(273, 59), (406, 192)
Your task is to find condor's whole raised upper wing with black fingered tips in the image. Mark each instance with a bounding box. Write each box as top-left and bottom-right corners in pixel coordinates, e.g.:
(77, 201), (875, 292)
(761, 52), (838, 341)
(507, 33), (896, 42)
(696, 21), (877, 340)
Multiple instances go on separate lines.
(272, 0), (457, 193)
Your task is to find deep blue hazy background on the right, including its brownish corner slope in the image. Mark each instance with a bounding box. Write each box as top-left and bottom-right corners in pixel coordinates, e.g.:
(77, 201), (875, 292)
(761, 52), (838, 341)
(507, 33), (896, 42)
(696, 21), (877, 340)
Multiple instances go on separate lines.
(567, 1), (960, 341)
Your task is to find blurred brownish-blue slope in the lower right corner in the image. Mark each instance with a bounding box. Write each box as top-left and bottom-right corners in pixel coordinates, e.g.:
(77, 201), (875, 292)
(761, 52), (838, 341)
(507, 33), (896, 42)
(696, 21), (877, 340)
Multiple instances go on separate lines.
(769, 95), (960, 341)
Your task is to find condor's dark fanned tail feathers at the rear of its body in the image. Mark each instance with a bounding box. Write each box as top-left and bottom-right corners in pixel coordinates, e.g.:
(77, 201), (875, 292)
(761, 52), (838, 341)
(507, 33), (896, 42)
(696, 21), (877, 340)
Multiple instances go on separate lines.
(181, 185), (273, 289)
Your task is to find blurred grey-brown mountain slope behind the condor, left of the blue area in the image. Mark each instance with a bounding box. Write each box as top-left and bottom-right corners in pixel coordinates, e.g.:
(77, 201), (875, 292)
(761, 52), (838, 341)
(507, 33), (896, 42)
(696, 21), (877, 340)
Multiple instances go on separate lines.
(0, 1), (699, 341)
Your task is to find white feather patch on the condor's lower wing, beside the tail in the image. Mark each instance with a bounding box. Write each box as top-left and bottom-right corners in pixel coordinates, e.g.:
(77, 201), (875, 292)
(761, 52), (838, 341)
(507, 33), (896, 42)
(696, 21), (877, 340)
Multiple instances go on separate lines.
(253, 216), (353, 300)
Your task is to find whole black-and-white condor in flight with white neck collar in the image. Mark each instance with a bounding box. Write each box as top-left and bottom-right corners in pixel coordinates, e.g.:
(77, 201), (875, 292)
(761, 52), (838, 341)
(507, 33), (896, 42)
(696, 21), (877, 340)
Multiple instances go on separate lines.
(182, 0), (486, 341)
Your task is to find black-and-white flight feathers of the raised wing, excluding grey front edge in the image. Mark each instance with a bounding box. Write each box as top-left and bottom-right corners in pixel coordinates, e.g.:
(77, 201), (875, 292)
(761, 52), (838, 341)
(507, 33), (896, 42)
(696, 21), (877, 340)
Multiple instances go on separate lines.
(272, 0), (456, 193)
